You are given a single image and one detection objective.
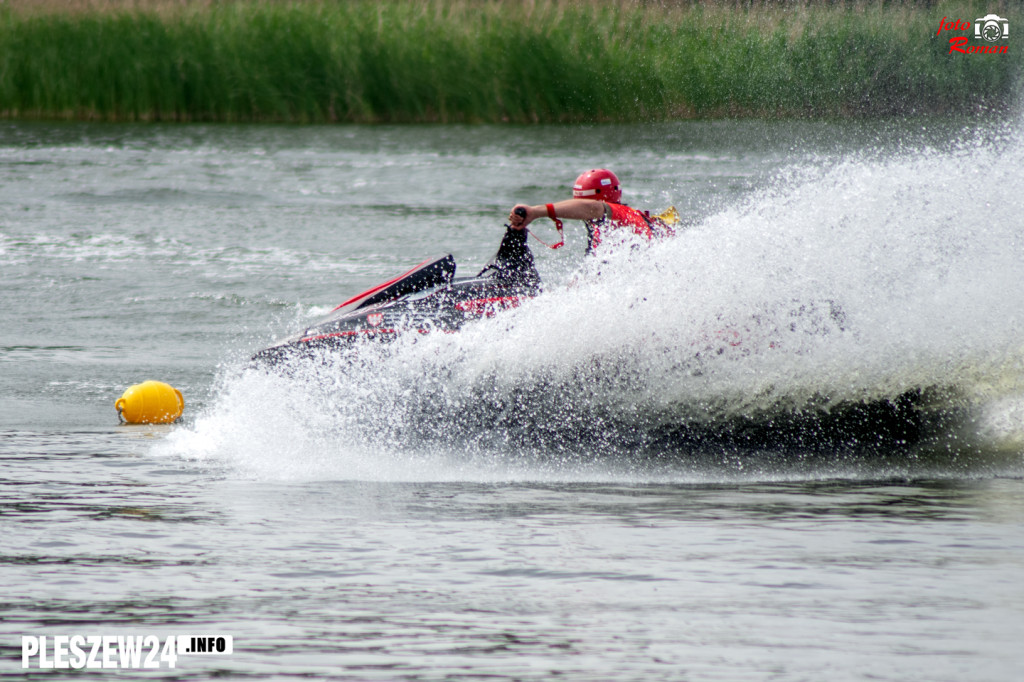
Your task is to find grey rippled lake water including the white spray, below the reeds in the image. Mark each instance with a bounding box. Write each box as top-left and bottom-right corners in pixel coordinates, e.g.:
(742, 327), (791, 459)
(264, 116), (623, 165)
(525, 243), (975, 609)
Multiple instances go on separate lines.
(0, 120), (1024, 682)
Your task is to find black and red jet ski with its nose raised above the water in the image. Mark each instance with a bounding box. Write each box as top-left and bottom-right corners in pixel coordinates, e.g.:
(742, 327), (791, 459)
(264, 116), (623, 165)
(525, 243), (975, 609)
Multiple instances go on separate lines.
(252, 220), (541, 365)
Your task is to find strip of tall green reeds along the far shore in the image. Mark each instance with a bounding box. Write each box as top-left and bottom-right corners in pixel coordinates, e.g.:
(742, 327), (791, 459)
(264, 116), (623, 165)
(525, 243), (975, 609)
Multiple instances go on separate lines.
(0, 0), (1024, 123)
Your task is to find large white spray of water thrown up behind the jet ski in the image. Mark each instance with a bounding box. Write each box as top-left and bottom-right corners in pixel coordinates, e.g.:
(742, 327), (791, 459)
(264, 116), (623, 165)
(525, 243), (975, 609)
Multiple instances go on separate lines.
(158, 119), (1024, 480)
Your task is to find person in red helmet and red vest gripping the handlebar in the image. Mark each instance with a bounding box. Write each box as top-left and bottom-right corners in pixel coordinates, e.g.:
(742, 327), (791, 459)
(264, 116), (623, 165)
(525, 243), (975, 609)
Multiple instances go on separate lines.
(509, 168), (673, 253)
